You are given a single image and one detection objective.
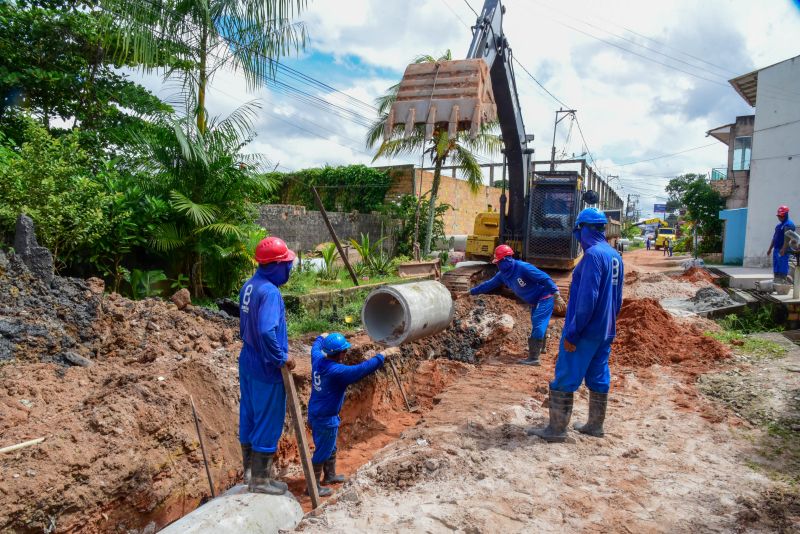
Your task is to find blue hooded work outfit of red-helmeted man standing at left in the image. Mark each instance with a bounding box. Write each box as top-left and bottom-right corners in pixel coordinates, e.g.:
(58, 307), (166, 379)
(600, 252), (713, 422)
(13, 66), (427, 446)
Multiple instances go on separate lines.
(239, 262), (292, 453)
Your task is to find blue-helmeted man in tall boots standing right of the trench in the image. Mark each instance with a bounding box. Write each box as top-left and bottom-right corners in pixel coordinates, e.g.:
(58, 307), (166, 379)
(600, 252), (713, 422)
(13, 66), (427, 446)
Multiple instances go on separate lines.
(528, 208), (624, 442)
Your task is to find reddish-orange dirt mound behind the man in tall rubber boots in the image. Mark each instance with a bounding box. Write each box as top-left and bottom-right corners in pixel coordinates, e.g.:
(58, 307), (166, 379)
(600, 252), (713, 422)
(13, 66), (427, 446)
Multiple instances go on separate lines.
(611, 299), (731, 367)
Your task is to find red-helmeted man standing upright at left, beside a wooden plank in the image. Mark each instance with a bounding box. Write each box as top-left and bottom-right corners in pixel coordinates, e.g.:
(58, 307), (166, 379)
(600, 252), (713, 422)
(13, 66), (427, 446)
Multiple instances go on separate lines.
(239, 237), (295, 495)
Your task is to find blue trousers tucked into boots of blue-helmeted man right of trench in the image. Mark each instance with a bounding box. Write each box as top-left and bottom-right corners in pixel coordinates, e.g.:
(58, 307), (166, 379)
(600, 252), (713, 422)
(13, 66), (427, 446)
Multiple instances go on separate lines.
(550, 336), (611, 393)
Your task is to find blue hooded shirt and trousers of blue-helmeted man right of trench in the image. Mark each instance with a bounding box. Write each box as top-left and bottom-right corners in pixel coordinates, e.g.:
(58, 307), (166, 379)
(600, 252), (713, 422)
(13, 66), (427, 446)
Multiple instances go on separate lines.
(550, 227), (624, 393)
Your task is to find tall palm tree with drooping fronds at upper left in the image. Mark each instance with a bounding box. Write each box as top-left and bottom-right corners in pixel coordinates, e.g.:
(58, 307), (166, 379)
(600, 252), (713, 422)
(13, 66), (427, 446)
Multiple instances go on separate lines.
(100, 0), (306, 133)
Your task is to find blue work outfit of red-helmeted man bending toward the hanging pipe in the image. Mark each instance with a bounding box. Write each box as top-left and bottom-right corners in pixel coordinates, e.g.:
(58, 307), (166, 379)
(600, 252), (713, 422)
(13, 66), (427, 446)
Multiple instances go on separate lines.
(469, 257), (558, 339)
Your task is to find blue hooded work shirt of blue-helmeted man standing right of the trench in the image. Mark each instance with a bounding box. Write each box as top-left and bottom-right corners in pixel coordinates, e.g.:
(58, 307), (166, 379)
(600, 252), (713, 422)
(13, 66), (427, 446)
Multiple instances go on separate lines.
(564, 229), (624, 345)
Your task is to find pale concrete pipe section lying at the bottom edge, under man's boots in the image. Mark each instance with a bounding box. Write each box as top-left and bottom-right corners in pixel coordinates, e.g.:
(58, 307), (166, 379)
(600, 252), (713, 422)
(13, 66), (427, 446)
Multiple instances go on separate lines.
(159, 484), (303, 534)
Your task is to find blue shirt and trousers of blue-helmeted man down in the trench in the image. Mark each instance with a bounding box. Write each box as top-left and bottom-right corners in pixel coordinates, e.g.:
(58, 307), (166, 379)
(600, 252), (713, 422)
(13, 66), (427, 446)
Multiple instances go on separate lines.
(308, 336), (383, 464)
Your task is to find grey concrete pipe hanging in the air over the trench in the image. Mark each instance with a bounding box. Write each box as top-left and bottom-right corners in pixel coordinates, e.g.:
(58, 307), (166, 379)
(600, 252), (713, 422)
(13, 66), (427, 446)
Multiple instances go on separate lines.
(361, 281), (453, 347)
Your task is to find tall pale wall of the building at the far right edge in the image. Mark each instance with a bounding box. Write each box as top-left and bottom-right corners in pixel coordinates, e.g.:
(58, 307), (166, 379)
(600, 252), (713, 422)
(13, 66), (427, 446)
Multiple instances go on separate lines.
(744, 57), (800, 267)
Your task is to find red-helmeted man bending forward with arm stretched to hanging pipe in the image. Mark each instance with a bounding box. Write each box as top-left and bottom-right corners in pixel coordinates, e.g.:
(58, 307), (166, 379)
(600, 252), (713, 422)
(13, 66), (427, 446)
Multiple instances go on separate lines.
(456, 245), (564, 365)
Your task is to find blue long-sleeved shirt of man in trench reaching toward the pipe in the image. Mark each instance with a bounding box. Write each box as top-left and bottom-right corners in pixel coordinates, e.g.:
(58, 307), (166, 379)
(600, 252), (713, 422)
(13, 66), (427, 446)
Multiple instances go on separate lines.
(308, 336), (383, 427)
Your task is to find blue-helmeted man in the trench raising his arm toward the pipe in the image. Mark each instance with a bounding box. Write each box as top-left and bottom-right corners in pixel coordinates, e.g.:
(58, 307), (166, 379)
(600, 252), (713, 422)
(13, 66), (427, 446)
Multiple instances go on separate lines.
(308, 332), (391, 497)
